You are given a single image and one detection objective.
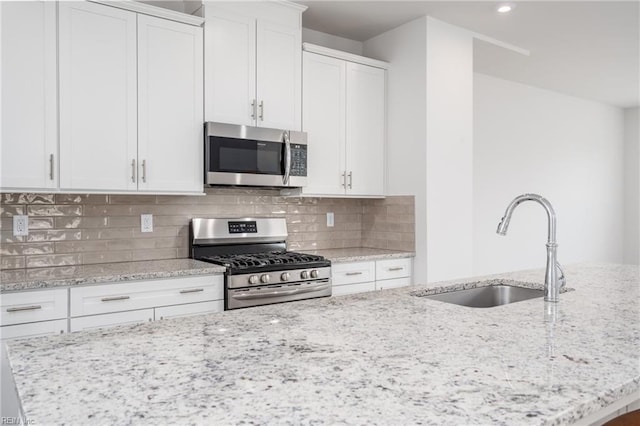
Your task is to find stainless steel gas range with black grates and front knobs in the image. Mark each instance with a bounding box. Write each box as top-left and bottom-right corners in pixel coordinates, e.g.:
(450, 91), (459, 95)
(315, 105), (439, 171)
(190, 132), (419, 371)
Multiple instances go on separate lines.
(189, 218), (331, 310)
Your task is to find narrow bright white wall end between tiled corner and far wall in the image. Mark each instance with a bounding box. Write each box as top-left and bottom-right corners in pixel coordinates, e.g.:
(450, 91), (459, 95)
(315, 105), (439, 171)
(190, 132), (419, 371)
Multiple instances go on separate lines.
(427, 18), (473, 282)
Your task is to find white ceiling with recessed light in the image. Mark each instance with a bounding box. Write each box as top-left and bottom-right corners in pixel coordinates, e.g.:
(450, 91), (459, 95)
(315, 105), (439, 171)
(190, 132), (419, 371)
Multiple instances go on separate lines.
(296, 0), (640, 108)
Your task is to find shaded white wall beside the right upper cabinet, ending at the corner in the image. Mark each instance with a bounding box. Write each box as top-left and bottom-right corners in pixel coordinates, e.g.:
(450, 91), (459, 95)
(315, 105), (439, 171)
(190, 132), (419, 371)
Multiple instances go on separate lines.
(364, 17), (427, 283)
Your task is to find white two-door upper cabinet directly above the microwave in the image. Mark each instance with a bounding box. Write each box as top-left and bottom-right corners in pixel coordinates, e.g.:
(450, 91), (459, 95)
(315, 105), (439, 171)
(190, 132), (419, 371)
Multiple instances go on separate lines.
(204, 1), (306, 130)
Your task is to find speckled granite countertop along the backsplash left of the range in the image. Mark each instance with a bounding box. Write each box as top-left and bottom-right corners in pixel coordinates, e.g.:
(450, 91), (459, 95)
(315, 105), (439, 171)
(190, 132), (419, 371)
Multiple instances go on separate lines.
(0, 259), (225, 293)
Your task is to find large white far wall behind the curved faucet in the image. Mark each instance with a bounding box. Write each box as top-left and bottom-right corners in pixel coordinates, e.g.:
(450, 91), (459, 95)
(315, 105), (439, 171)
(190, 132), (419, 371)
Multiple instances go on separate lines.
(473, 74), (624, 275)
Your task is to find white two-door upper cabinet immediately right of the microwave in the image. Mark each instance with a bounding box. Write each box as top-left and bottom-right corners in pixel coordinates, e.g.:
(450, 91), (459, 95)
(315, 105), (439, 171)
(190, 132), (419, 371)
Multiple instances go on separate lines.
(302, 44), (387, 197)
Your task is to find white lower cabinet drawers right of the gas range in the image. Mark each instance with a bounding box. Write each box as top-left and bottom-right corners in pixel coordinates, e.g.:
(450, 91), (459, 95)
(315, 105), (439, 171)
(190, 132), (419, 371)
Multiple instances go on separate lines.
(331, 258), (412, 296)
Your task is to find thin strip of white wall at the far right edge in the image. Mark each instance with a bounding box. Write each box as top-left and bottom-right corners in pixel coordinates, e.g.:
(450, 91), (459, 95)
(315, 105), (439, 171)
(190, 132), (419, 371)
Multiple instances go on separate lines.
(624, 108), (640, 265)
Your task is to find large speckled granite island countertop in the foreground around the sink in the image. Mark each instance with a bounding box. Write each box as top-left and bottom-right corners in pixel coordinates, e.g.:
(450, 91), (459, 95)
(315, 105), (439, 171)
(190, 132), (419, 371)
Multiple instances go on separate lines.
(7, 265), (640, 425)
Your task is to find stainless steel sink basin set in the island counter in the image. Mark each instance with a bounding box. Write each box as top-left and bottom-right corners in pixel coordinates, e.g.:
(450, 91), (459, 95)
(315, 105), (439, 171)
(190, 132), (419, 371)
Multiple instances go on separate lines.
(421, 284), (544, 308)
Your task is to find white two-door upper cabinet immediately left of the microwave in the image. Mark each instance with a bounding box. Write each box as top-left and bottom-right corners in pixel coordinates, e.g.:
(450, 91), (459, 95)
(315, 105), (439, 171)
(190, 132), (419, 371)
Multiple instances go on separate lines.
(58, 2), (203, 193)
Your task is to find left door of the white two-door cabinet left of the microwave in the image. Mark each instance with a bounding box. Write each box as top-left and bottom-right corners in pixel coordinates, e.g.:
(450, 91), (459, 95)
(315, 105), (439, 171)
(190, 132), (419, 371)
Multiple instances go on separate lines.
(59, 2), (137, 190)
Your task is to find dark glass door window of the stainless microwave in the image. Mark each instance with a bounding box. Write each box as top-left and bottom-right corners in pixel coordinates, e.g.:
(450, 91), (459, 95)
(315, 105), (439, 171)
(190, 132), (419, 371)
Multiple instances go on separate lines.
(209, 136), (284, 176)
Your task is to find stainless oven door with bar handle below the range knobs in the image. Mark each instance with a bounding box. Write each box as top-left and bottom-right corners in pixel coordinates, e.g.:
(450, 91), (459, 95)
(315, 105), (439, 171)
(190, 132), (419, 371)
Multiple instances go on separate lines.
(225, 278), (331, 310)
